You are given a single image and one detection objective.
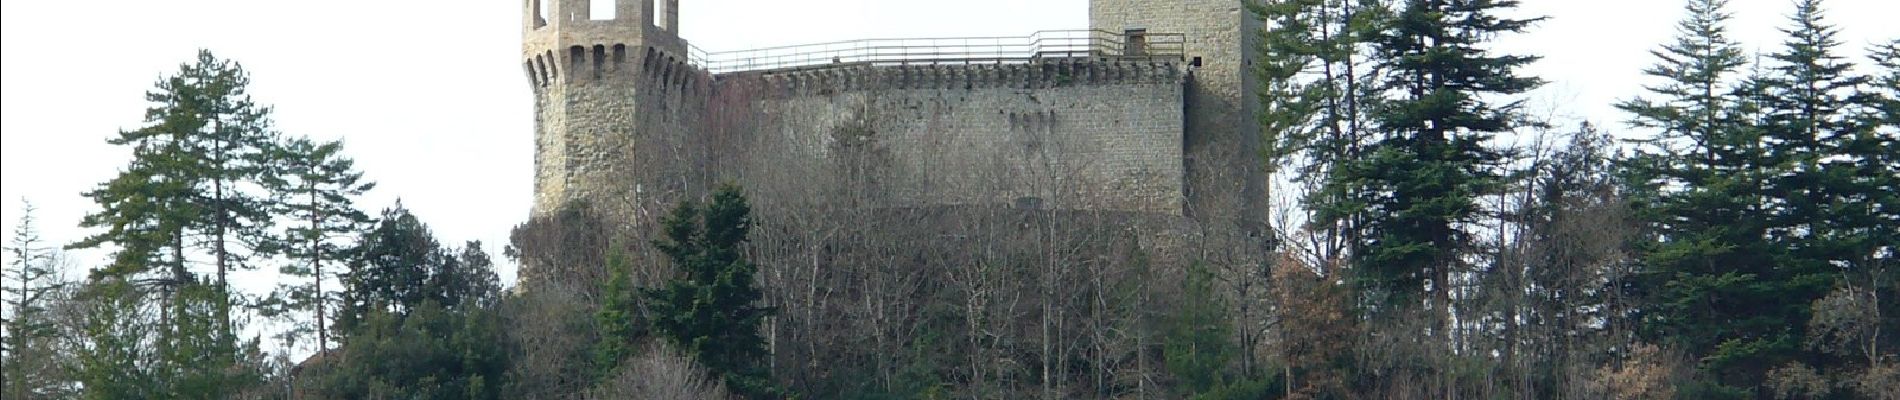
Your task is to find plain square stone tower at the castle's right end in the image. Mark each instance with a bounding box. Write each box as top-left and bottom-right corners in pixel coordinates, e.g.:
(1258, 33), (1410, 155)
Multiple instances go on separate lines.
(1089, 0), (1265, 233)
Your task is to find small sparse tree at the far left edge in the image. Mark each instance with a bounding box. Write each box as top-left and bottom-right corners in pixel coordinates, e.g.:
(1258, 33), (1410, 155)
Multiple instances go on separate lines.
(0, 201), (65, 398)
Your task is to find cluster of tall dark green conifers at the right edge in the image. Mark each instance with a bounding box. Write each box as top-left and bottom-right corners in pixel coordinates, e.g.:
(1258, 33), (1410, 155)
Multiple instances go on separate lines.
(1621, 0), (1900, 398)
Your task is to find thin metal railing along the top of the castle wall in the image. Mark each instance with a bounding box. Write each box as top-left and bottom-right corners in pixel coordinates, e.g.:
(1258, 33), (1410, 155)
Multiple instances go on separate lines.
(690, 30), (1188, 74)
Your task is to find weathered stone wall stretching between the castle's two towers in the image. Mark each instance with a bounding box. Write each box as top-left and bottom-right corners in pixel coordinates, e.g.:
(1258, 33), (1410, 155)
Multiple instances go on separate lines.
(714, 63), (1186, 214)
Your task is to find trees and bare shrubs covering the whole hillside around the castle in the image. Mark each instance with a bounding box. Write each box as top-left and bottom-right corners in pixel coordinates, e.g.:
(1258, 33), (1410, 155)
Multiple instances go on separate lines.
(0, 0), (1900, 398)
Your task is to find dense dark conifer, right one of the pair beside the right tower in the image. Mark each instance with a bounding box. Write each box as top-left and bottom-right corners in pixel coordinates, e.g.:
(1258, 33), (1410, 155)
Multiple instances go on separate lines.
(1330, 0), (1541, 318)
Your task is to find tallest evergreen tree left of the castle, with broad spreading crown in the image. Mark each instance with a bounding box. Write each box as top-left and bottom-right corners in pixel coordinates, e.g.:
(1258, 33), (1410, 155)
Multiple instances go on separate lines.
(70, 51), (285, 356)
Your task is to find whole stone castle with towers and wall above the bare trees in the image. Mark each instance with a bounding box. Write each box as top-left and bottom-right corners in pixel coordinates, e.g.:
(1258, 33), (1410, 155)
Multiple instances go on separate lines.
(523, 0), (1265, 274)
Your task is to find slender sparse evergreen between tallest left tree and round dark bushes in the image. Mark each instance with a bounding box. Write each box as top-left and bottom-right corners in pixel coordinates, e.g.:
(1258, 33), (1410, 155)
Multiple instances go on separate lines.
(274, 138), (376, 351)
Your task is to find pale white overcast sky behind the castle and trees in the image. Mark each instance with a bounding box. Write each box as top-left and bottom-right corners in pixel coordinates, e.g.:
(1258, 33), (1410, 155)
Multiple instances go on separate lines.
(0, 0), (1900, 288)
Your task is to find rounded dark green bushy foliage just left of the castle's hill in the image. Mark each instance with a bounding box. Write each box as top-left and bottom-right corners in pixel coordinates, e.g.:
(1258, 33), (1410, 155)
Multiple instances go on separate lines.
(308, 207), (507, 398)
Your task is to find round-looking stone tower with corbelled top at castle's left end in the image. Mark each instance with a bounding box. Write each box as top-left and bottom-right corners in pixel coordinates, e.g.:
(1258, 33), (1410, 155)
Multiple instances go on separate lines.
(523, 0), (697, 214)
